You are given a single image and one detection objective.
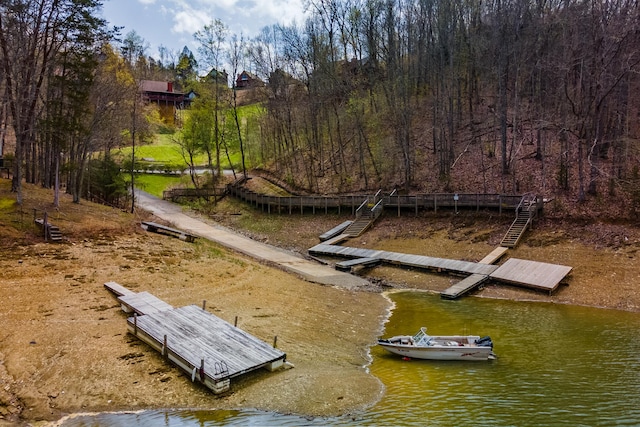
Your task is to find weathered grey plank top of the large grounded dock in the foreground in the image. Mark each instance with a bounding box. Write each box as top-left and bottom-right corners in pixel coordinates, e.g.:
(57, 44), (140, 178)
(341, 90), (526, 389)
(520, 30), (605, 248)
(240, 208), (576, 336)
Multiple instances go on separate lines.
(127, 305), (286, 382)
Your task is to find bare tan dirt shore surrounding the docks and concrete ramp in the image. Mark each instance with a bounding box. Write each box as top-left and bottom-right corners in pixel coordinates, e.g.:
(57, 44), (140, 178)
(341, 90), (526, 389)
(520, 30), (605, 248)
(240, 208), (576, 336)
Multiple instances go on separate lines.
(0, 182), (640, 425)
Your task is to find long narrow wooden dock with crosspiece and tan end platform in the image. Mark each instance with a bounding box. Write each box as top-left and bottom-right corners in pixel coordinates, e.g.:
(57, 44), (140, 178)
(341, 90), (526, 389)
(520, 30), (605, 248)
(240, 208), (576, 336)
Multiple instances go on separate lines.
(309, 243), (572, 299)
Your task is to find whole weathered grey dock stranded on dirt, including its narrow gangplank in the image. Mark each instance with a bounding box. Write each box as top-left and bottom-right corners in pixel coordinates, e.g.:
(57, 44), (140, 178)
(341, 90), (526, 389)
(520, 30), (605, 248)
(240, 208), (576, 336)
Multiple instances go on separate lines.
(105, 282), (287, 393)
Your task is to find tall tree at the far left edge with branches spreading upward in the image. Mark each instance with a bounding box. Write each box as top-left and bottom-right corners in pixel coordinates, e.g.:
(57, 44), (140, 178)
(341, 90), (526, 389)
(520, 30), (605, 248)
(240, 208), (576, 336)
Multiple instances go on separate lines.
(0, 0), (104, 204)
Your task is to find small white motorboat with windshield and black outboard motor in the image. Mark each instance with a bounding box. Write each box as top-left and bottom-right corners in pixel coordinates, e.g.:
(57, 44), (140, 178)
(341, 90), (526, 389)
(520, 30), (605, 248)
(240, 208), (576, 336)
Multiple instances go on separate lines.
(378, 327), (496, 360)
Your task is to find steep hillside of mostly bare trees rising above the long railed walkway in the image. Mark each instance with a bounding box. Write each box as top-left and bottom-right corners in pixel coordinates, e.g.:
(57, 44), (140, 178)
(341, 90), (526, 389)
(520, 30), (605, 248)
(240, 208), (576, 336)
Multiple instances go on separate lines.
(251, 0), (640, 221)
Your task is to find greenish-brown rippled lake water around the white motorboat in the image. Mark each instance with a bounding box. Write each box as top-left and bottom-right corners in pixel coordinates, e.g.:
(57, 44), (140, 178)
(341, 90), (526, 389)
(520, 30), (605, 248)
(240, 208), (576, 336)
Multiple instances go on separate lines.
(62, 292), (640, 427)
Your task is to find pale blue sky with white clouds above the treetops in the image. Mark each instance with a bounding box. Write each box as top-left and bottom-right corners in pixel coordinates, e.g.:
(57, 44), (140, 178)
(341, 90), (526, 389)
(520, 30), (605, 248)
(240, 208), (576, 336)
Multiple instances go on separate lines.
(102, 0), (304, 57)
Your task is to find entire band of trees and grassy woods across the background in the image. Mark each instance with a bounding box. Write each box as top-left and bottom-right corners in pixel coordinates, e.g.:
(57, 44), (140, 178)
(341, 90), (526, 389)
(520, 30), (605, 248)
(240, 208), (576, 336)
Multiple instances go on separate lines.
(0, 0), (640, 219)
